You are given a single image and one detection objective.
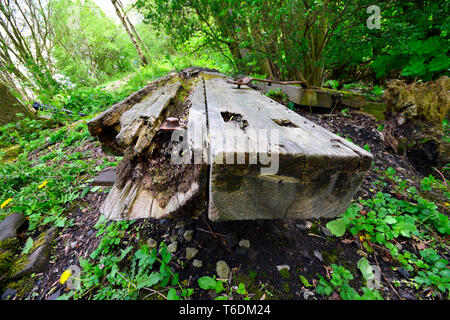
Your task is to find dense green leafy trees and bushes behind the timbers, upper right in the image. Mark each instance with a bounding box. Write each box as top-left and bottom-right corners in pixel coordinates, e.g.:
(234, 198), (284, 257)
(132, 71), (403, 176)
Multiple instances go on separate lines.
(137, 0), (450, 85)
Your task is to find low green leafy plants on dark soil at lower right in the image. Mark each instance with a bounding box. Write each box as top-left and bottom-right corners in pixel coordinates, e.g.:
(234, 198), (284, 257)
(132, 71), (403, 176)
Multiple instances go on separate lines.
(327, 168), (450, 295)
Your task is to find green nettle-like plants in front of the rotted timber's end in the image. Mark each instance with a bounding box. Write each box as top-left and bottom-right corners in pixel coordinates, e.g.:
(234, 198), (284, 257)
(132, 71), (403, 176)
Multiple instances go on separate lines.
(61, 216), (193, 300)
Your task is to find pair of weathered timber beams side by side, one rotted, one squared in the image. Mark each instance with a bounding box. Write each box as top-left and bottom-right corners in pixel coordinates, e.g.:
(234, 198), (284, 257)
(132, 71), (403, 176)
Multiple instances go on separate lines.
(88, 68), (372, 221)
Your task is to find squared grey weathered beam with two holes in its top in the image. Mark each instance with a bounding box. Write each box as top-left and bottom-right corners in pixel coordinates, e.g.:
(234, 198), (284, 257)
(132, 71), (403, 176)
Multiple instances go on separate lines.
(205, 77), (372, 220)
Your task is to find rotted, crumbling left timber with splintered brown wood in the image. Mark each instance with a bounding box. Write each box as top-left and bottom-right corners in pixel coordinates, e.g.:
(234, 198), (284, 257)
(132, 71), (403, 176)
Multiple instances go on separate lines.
(88, 70), (207, 220)
